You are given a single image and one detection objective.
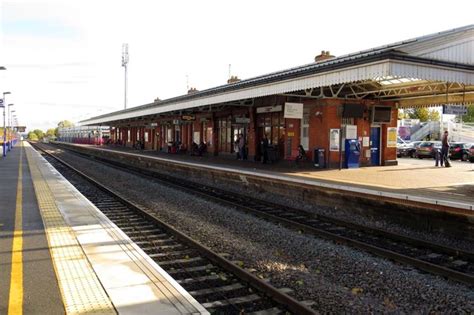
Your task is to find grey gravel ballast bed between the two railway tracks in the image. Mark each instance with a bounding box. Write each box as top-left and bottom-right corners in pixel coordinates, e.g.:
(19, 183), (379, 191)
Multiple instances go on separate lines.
(49, 148), (474, 313)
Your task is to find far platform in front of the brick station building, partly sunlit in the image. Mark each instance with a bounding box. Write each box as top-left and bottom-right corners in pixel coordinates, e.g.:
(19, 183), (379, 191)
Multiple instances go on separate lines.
(70, 146), (474, 215)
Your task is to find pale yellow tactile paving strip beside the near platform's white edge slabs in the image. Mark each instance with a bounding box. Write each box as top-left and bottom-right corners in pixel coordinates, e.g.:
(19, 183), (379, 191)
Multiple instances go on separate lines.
(25, 147), (117, 314)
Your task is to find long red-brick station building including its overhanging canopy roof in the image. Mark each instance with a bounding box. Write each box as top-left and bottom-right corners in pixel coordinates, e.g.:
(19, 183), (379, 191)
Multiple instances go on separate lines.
(81, 25), (474, 168)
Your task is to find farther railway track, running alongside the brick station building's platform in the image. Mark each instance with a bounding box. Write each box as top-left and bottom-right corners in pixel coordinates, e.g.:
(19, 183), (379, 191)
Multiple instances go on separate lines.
(41, 143), (474, 286)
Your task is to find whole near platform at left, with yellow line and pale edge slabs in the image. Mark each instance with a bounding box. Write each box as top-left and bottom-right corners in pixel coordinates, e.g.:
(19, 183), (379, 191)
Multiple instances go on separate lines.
(0, 142), (208, 314)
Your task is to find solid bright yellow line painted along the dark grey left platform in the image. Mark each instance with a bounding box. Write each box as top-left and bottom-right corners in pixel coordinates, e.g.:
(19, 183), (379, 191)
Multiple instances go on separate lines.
(8, 147), (23, 315)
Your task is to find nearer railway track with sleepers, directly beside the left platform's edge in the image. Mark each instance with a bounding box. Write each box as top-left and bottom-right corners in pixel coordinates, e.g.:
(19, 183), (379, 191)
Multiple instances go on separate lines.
(34, 145), (316, 315)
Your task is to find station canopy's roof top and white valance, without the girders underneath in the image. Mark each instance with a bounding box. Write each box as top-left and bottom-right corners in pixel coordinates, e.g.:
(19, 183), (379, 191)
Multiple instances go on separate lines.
(81, 25), (474, 125)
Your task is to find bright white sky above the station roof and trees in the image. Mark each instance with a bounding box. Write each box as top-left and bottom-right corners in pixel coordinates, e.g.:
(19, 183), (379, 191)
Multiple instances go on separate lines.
(0, 0), (474, 130)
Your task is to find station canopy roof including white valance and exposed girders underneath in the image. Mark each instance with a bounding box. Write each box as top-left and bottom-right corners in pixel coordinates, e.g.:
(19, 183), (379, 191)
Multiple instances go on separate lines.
(81, 25), (474, 125)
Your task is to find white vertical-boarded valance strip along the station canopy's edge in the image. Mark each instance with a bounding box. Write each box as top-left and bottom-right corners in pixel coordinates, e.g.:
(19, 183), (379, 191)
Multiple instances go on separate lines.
(82, 59), (474, 125)
